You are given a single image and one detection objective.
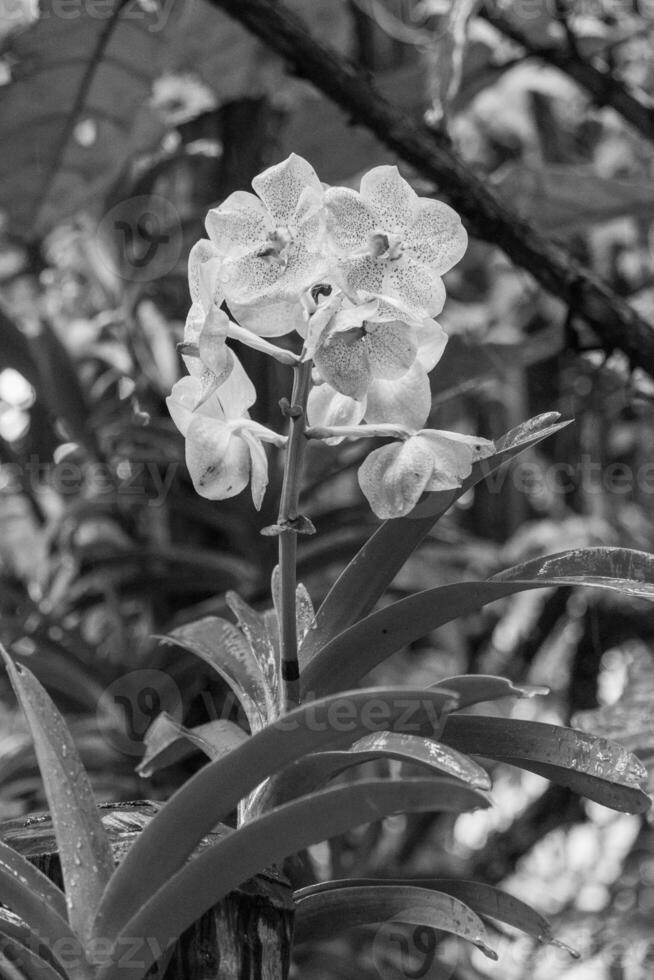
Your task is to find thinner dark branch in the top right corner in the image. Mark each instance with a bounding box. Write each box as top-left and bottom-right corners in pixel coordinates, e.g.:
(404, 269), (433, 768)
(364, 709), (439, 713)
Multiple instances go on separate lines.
(481, 10), (654, 140)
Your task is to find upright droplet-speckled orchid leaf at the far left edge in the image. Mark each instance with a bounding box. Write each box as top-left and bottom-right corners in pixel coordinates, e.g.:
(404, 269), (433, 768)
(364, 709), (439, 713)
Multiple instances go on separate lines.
(0, 646), (114, 942)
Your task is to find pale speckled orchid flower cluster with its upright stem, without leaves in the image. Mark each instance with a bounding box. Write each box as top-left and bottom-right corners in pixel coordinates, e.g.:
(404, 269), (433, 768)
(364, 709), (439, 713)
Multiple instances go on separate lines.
(168, 154), (494, 707)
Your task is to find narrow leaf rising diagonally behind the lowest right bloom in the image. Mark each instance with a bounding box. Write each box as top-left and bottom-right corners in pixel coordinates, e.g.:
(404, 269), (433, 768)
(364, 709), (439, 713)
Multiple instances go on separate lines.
(300, 412), (570, 666)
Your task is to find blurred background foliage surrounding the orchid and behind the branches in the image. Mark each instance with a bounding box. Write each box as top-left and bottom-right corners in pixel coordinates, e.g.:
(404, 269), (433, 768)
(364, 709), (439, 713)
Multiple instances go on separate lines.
(0, 0), (654, 980)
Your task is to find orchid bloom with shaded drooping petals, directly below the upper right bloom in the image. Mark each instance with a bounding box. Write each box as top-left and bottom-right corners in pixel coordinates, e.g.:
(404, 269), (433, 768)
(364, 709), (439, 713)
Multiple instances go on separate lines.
(306, 293), (447, 430)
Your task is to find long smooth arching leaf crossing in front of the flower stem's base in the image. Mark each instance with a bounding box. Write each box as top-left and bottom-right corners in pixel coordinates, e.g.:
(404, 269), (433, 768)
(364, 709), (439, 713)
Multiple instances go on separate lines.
(94, 687), (456, 939)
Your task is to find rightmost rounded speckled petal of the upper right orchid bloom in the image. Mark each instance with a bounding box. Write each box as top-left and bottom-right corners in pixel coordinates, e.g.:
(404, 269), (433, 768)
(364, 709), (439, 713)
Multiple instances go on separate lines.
(405, 198), (468, 275)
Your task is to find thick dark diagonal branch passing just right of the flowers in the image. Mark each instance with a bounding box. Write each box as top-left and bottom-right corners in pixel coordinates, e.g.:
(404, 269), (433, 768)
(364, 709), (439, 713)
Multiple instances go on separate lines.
(206, 0), (654, 376)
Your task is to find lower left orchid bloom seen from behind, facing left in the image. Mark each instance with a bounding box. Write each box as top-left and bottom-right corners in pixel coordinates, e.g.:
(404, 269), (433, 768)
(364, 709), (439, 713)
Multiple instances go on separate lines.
(166, 352), (286, 510)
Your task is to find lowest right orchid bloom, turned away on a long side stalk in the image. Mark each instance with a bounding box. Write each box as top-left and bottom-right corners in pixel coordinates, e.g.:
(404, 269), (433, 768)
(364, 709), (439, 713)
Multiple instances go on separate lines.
(359, 429), (495, 520)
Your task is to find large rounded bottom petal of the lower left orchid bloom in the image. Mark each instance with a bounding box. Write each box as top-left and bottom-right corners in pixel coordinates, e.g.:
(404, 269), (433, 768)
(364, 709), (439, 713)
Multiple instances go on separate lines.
(186, 415), (250, 500)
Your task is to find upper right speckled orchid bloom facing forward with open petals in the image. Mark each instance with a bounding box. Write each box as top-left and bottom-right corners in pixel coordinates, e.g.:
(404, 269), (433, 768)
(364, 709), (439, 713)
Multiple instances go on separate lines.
(325, 166), (468, 318)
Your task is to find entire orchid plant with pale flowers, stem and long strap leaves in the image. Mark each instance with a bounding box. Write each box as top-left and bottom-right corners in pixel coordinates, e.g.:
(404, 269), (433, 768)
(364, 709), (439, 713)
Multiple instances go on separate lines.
(0, 156), (654, 980)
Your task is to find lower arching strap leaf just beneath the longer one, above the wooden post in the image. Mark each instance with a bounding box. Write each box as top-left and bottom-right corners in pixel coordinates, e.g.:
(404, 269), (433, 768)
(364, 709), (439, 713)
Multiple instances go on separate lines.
(97, 784), (488, 980)
